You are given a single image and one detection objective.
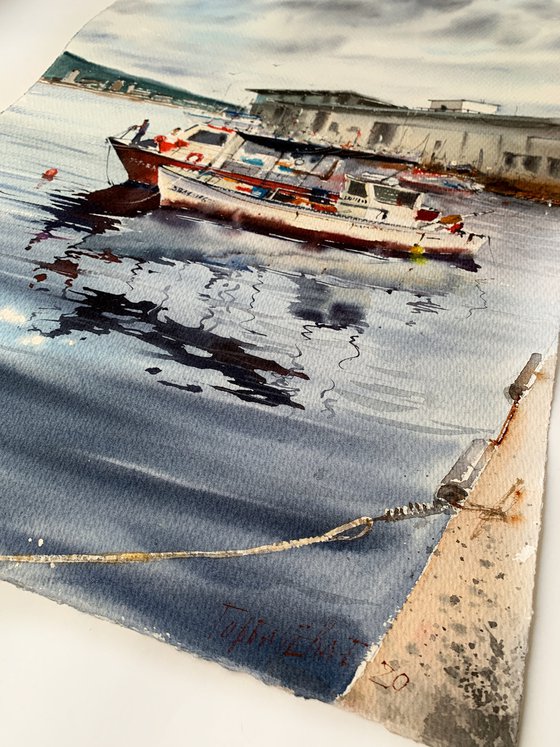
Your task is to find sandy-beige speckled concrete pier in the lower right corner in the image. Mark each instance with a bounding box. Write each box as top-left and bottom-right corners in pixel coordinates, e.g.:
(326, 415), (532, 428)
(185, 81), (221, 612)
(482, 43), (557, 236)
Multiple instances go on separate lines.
(338, 357), (555, 747)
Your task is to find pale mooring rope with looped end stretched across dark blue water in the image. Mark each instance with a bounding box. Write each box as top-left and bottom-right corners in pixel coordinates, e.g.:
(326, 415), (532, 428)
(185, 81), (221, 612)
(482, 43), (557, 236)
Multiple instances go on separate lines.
(0, 516), (375, 565)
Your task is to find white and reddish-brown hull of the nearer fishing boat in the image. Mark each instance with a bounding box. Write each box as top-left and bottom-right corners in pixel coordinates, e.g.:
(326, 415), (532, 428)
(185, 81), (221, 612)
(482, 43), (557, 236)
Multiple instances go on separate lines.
(158, 168), (486, 257)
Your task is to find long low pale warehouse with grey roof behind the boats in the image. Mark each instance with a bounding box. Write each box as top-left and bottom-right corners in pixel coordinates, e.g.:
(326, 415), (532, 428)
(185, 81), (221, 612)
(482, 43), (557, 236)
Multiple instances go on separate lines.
(249, 89), (560, 189)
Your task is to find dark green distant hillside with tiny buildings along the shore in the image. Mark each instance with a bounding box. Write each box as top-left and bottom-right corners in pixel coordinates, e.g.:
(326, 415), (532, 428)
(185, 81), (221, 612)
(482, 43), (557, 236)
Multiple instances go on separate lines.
(43, 52), (241, 112)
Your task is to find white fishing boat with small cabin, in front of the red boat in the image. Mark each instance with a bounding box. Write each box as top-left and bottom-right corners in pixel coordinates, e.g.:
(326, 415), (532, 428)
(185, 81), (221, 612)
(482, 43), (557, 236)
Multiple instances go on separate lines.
(158, 166), (487, 257)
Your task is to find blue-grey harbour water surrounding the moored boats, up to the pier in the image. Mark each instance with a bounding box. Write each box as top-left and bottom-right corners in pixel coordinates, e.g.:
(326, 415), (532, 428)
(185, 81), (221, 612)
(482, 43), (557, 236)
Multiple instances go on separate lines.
(0, 84), (560, 700)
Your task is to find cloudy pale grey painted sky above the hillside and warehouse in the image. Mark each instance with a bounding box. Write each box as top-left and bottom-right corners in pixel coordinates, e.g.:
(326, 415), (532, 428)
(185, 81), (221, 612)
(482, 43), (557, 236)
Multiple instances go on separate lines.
(69, 0), (560, 116)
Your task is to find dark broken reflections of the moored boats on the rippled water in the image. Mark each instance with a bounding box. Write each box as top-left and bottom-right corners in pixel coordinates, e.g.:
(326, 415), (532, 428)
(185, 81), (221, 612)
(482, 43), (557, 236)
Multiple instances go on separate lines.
(26, 183), (382, 409)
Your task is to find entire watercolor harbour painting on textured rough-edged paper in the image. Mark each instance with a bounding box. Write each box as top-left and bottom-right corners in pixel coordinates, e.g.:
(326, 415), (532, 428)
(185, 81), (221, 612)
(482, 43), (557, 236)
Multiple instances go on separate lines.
(0, 0), (560, 747)
